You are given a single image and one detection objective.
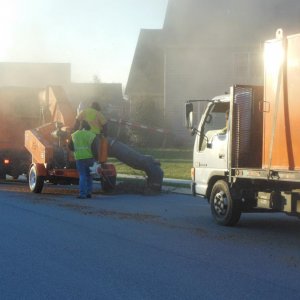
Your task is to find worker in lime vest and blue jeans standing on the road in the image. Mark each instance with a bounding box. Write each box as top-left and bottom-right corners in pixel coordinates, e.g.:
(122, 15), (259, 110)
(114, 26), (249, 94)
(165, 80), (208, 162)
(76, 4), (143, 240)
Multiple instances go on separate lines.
(69, 120), (97, 199)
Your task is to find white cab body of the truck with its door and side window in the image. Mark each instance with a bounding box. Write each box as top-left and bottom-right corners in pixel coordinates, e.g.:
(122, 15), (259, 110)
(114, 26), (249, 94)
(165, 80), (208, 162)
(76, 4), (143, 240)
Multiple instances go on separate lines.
(193, 102), (229, 195)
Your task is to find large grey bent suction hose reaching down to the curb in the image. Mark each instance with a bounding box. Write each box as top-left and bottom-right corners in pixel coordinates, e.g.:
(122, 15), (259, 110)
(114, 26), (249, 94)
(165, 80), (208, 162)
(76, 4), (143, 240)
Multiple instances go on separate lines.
(108, 138), (164, 191)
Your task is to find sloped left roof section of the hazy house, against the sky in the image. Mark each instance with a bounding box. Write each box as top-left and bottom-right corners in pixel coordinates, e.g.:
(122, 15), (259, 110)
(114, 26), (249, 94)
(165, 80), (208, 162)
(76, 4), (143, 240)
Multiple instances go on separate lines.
(125, 29), (164, 95)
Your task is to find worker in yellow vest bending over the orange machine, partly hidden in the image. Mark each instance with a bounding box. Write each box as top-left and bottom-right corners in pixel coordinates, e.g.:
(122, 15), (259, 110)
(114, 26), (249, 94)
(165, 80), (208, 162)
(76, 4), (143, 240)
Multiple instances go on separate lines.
(74, 102), (108, 161)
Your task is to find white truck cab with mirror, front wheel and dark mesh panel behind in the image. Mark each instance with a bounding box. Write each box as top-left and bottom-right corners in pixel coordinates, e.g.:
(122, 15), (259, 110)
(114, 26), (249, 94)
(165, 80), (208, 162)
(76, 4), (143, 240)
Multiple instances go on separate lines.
(186, 85), (263, 226)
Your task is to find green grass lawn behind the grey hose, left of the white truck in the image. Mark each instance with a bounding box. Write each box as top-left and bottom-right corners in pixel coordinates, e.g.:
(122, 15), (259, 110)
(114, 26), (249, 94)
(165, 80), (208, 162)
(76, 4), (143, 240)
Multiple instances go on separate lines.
(109, 148), (193, 180)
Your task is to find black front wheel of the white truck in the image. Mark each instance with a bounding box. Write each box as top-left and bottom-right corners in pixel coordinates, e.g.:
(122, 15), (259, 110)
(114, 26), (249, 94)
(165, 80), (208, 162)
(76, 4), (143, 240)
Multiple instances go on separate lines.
(210, 180), (241, 226)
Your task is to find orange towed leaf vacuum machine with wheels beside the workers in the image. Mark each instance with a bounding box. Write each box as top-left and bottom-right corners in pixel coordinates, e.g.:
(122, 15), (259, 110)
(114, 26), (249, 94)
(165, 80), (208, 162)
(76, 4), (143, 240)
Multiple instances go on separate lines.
(25, 86), (116, 193)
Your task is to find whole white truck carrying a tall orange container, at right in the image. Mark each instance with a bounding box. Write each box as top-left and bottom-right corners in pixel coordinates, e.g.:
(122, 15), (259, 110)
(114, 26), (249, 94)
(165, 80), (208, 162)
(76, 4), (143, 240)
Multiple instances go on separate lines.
(186, 30), (300, 226)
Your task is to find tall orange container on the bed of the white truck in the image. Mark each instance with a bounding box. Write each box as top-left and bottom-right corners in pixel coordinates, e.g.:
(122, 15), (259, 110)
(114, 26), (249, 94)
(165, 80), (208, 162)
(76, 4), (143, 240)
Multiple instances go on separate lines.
(263, 30), (300, 171)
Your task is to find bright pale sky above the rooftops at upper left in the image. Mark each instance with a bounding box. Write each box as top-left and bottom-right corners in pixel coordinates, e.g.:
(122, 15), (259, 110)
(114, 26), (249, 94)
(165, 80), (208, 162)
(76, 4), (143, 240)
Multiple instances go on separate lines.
(0, 0), (168, 87)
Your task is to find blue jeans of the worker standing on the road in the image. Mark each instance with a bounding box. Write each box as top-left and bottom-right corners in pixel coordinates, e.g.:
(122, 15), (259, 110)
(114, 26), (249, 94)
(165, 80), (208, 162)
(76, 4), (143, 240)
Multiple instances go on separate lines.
(76, 158), (94, 197)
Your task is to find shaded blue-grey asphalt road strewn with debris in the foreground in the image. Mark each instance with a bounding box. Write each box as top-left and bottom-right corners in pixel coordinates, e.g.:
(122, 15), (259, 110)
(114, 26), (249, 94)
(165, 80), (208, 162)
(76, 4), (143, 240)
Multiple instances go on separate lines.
(0, 183), (300, 299)
